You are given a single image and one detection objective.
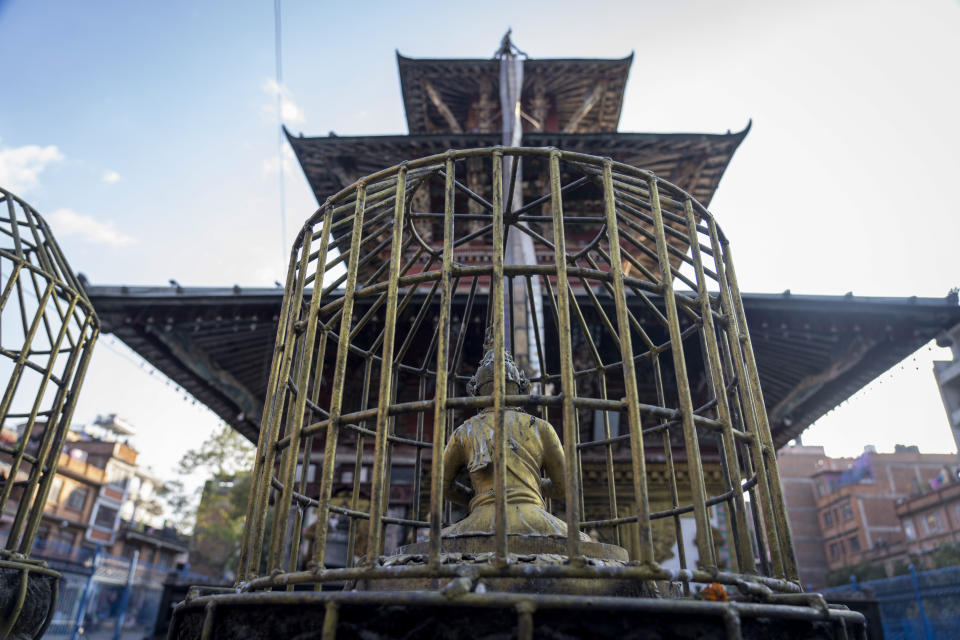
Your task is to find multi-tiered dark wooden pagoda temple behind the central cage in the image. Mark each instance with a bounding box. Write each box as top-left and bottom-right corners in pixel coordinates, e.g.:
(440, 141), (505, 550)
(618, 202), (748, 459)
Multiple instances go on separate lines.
(88, 40), (960, 565)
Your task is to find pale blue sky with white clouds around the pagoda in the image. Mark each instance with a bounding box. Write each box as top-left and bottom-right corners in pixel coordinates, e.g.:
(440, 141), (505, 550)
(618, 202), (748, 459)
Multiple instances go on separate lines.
(0, 0), (960, 492)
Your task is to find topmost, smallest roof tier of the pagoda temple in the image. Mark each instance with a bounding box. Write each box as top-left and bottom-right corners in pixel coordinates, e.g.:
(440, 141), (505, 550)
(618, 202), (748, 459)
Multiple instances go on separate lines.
(397, 53), (633, 135)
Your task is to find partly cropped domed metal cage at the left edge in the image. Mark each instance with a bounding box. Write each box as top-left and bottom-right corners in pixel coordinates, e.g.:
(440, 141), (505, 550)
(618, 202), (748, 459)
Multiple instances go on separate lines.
(0, 189), (99, 637)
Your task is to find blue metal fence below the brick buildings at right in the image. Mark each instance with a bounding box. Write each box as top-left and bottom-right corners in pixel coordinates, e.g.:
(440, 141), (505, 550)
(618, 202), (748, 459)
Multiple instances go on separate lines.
(824, 565), (960, 640)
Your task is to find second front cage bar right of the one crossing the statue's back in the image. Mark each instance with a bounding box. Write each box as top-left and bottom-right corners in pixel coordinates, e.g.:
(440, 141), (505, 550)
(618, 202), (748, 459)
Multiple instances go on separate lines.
(603, 160), (655, 566)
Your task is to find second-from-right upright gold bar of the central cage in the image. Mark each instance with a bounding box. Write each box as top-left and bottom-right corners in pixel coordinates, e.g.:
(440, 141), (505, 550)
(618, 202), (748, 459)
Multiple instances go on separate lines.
(709, 218), (785, 575)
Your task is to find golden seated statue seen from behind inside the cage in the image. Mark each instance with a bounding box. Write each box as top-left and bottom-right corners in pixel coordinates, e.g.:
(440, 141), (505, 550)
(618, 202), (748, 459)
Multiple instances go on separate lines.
(442, 349), (590, 541)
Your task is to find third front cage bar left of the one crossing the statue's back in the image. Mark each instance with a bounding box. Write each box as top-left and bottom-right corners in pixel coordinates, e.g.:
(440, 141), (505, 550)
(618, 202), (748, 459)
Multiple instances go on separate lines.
(313, 188), (367, 572)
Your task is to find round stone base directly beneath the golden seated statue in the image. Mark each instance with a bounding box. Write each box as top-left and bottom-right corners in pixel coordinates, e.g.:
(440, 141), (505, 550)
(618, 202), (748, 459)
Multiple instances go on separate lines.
(356, 535), (636, 596)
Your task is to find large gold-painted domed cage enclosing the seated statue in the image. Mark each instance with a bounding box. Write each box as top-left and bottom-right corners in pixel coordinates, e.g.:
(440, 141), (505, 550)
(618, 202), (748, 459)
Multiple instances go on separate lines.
(238, 148), (800, 595)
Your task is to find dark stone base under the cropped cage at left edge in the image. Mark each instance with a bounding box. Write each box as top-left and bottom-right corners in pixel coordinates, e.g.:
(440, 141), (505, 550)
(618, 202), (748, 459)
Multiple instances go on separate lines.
(0, 560), (60, 640)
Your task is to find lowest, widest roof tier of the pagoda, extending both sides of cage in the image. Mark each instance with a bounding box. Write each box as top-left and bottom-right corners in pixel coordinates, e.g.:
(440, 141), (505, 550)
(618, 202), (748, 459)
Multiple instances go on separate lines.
(87, 286), (960, 446)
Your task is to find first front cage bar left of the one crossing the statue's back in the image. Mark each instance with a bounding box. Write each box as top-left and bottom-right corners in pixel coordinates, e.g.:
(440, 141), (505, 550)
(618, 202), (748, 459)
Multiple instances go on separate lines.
(430, 154), (456, 568)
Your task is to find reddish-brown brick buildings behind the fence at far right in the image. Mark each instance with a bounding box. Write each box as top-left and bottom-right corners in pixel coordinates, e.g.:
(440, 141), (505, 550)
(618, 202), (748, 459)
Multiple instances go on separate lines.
(778, 445), (960, 587)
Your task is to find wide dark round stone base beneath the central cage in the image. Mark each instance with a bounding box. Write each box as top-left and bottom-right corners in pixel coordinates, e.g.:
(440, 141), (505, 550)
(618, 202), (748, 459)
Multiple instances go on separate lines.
(169, 591), (864, 640)
